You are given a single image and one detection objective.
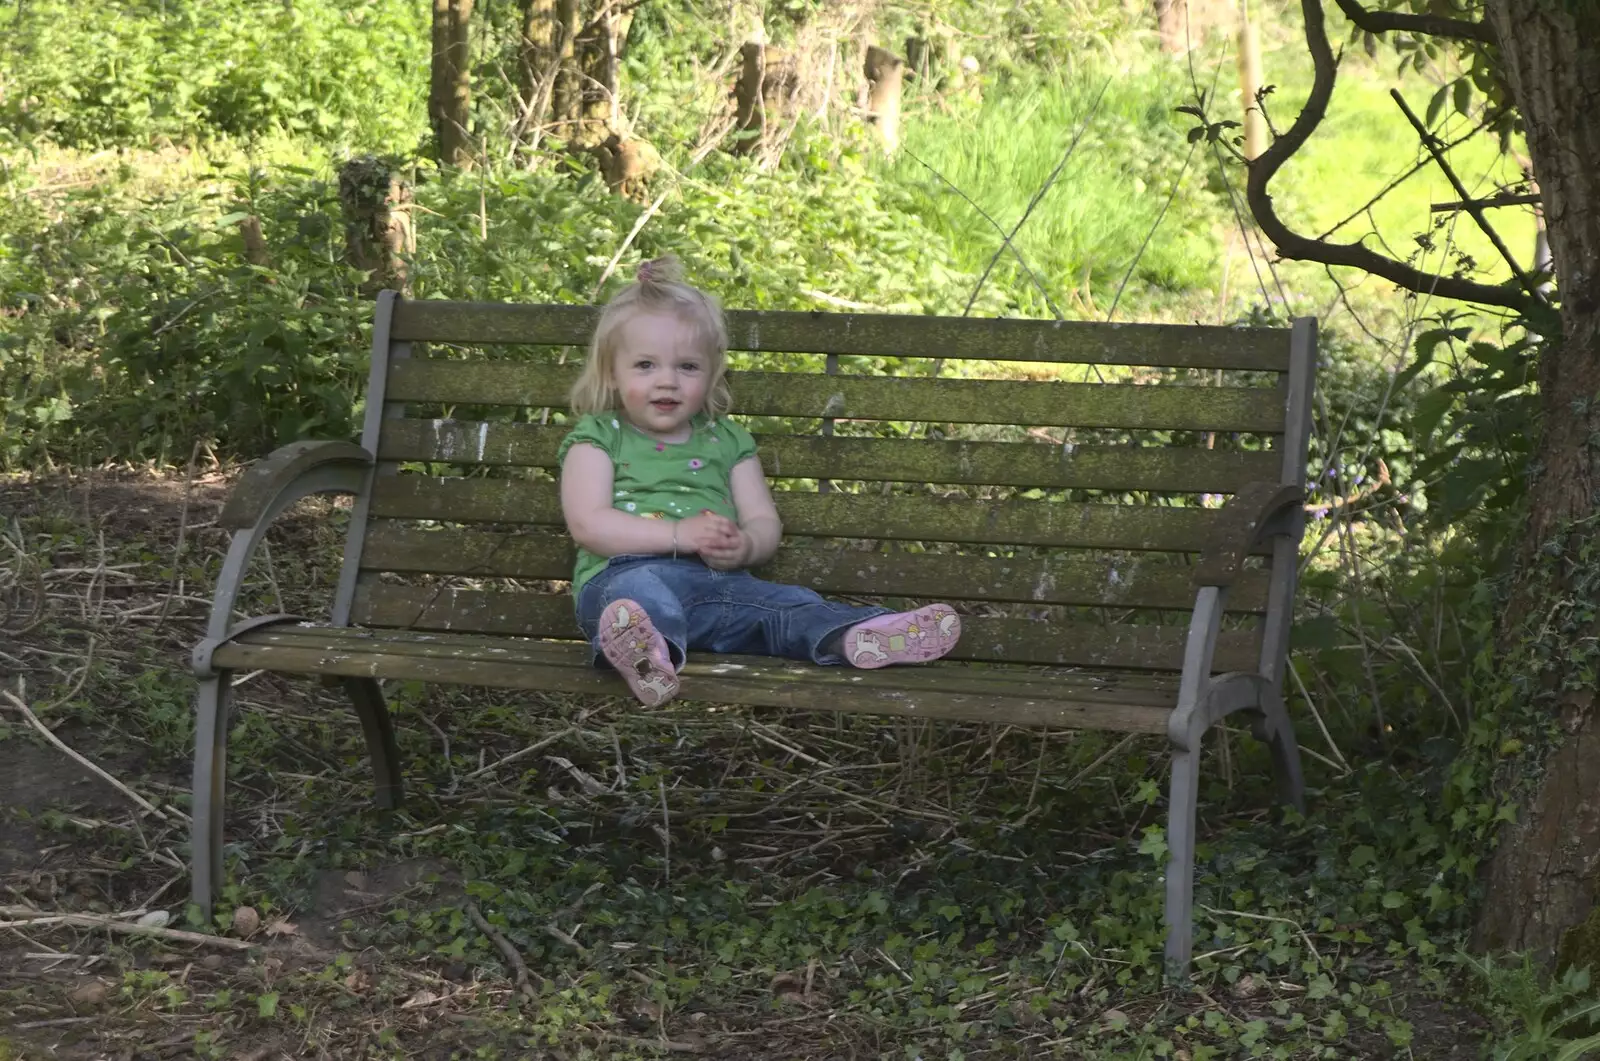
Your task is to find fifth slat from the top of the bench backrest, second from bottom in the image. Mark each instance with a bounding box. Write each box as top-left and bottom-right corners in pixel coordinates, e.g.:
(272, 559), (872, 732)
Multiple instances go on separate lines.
(362, 520), (1267, 613)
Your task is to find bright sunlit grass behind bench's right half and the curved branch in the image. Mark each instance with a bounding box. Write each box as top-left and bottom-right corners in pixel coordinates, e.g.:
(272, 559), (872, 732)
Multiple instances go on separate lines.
(878, 1), (1533, 340)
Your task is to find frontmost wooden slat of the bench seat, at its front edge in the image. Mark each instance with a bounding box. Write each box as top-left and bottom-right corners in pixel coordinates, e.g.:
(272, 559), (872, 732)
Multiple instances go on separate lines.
(214, 642), (1171, 735)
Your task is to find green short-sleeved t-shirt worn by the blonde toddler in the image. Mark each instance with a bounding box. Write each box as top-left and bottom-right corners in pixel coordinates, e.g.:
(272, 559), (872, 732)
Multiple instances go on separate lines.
(557, 413), (755, 597)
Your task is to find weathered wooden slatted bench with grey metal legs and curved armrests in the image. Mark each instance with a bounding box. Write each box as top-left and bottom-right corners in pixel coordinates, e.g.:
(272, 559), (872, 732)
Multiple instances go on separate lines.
(194, 291), (1317, 976)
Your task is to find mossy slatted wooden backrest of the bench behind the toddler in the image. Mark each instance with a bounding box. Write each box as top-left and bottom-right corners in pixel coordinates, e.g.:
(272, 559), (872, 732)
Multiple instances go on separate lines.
(334, 291), (1315, 671)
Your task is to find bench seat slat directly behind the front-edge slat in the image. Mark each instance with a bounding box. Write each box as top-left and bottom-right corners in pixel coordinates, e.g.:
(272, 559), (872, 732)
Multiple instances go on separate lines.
(242, 623), (1178, 709)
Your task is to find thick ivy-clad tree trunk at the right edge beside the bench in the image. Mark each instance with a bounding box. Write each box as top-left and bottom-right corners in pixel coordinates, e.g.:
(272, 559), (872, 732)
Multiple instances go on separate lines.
(1474, 0), (1600, 965)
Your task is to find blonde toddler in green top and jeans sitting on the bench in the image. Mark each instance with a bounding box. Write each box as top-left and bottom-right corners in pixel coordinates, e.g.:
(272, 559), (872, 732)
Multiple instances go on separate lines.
(557, 258), (962, 707)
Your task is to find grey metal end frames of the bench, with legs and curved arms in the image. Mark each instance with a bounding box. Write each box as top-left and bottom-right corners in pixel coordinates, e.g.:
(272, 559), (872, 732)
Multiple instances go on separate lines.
(192, 291), (1317, 979)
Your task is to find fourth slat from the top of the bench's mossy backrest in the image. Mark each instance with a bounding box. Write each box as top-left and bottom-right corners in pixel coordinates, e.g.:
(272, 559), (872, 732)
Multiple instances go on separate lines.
(371, 475), (1266, 552)
